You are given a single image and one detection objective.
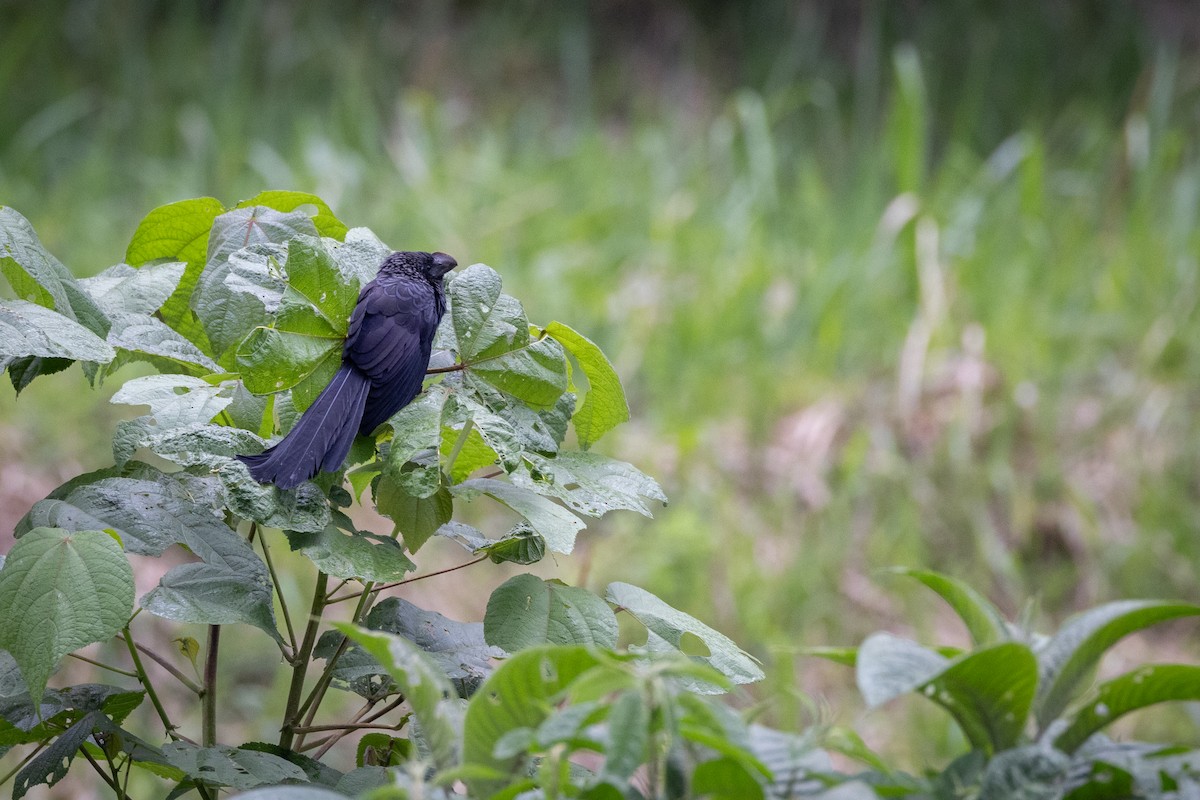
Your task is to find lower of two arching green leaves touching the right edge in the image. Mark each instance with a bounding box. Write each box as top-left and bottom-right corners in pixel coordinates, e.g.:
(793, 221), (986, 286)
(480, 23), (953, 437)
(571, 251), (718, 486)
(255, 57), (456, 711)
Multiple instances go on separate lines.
(1054, 664), (1200, 753)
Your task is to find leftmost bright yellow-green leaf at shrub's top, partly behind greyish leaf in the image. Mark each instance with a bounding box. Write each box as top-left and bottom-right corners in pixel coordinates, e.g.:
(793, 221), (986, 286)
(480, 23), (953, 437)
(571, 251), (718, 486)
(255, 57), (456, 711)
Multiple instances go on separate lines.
(125, 197), (224, 330)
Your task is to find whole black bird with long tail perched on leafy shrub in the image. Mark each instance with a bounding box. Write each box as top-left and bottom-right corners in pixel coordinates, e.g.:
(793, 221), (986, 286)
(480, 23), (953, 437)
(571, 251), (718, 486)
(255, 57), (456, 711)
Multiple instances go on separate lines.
(238, 252), (458, 489)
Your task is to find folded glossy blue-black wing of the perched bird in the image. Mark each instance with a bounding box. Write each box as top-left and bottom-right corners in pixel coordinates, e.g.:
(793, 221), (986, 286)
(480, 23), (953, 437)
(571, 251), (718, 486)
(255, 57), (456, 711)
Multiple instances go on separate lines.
(342, 278), (439, 433)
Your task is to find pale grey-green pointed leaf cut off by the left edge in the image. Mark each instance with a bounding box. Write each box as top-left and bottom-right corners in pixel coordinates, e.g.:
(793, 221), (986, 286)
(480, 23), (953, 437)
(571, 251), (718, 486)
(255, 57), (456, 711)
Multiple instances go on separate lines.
(0, 300), (116, 367)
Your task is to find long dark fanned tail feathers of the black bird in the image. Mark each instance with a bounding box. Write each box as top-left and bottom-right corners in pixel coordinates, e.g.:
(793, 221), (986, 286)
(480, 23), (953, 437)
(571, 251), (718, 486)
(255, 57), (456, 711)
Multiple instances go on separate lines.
(238, 363), (371, 489)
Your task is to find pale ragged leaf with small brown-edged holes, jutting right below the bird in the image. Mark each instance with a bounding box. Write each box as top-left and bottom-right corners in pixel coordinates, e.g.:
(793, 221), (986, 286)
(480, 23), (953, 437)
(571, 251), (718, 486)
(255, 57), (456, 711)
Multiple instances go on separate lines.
(511, 451), (667, 517)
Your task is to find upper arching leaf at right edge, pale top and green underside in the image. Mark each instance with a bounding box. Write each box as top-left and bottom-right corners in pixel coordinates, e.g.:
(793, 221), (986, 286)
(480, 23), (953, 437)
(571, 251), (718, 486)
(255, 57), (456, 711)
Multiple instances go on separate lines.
(1034, 600), (1200, 730)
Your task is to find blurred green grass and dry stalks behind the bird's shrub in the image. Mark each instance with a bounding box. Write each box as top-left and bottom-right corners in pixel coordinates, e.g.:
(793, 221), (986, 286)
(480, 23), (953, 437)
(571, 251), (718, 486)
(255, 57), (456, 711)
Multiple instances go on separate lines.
(0, 0), (1200, 777)
